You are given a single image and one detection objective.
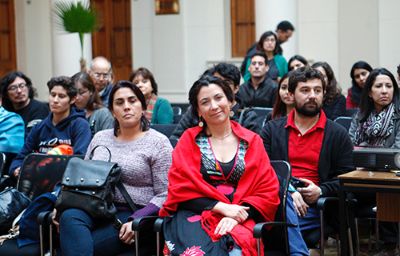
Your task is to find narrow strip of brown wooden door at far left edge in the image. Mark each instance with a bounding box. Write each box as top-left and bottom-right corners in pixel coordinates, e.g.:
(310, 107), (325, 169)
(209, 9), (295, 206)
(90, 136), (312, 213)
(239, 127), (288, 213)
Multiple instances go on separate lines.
(0, 0), (17, 77)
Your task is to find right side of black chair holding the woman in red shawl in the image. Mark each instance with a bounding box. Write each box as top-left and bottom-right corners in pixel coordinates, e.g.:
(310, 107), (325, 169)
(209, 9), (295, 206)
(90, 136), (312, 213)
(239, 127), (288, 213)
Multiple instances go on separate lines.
(254, 160), (296, 255)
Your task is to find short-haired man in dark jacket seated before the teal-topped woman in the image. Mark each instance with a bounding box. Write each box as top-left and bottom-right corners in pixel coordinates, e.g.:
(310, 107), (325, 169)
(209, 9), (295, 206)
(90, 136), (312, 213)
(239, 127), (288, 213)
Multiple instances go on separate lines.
(238, 52), (278, 108)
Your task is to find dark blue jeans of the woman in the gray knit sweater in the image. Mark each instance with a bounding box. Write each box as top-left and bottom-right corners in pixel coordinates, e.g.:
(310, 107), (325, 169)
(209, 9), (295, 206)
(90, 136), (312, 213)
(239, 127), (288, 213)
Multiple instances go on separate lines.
(60, 209), (134, 256)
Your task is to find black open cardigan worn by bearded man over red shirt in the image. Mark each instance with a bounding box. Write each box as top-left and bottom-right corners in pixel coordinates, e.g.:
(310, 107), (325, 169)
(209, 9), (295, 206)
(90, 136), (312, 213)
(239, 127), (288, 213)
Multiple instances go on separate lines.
(261, 114), (354, 196)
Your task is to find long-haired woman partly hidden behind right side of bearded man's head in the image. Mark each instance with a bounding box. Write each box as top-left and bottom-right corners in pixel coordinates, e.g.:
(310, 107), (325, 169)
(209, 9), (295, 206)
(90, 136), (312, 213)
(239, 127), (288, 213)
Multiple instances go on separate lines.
(312, 62), (346, 120)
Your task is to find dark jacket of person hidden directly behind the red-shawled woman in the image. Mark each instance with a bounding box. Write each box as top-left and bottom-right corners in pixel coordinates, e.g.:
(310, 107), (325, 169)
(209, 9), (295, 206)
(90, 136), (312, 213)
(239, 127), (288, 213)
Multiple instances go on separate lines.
(169, 103), (261, 140)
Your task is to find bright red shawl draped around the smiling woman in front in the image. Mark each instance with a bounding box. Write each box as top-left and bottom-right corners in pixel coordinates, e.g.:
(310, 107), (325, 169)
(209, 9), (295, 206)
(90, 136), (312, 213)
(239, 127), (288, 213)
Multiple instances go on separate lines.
(160, 121), (279, 256)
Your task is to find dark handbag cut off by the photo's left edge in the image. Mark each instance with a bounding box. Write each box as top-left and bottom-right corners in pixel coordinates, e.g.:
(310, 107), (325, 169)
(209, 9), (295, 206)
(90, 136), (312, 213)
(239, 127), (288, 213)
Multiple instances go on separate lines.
(0, 188), (31, 234)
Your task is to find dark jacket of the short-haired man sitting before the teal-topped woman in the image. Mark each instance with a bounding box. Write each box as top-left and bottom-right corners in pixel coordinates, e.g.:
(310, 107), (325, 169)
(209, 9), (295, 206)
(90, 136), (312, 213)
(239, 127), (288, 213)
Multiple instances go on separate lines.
(237, 78), (278, 108)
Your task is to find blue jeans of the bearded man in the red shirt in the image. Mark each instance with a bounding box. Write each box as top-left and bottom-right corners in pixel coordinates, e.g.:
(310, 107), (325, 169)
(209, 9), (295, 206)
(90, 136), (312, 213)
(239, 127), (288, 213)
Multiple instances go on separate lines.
(286, 193), (309, 255)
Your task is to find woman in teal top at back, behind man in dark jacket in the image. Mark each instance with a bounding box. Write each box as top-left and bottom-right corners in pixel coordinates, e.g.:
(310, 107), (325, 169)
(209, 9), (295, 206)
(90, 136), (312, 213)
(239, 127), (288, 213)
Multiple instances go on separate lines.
(243, 31), (288, 82)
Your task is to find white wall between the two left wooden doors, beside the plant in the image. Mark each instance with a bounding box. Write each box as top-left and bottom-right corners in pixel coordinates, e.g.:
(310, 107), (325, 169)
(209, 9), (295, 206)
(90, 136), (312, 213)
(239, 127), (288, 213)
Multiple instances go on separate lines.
(14, 0), (92, 101)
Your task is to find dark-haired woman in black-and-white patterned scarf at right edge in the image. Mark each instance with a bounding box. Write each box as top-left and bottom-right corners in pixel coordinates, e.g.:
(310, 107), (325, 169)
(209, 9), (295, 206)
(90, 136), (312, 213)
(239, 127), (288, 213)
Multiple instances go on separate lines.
(349, 68), (400, 148)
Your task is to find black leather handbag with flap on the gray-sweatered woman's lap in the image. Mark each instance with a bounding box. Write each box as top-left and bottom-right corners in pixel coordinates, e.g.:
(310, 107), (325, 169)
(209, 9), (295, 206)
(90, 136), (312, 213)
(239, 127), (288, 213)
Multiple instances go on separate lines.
(56, 145), (135, 219)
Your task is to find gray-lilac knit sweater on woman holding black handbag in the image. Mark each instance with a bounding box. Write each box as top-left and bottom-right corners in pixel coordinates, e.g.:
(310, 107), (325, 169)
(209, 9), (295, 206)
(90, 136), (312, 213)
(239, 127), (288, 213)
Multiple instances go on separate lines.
(85, 129), (172, 208)
